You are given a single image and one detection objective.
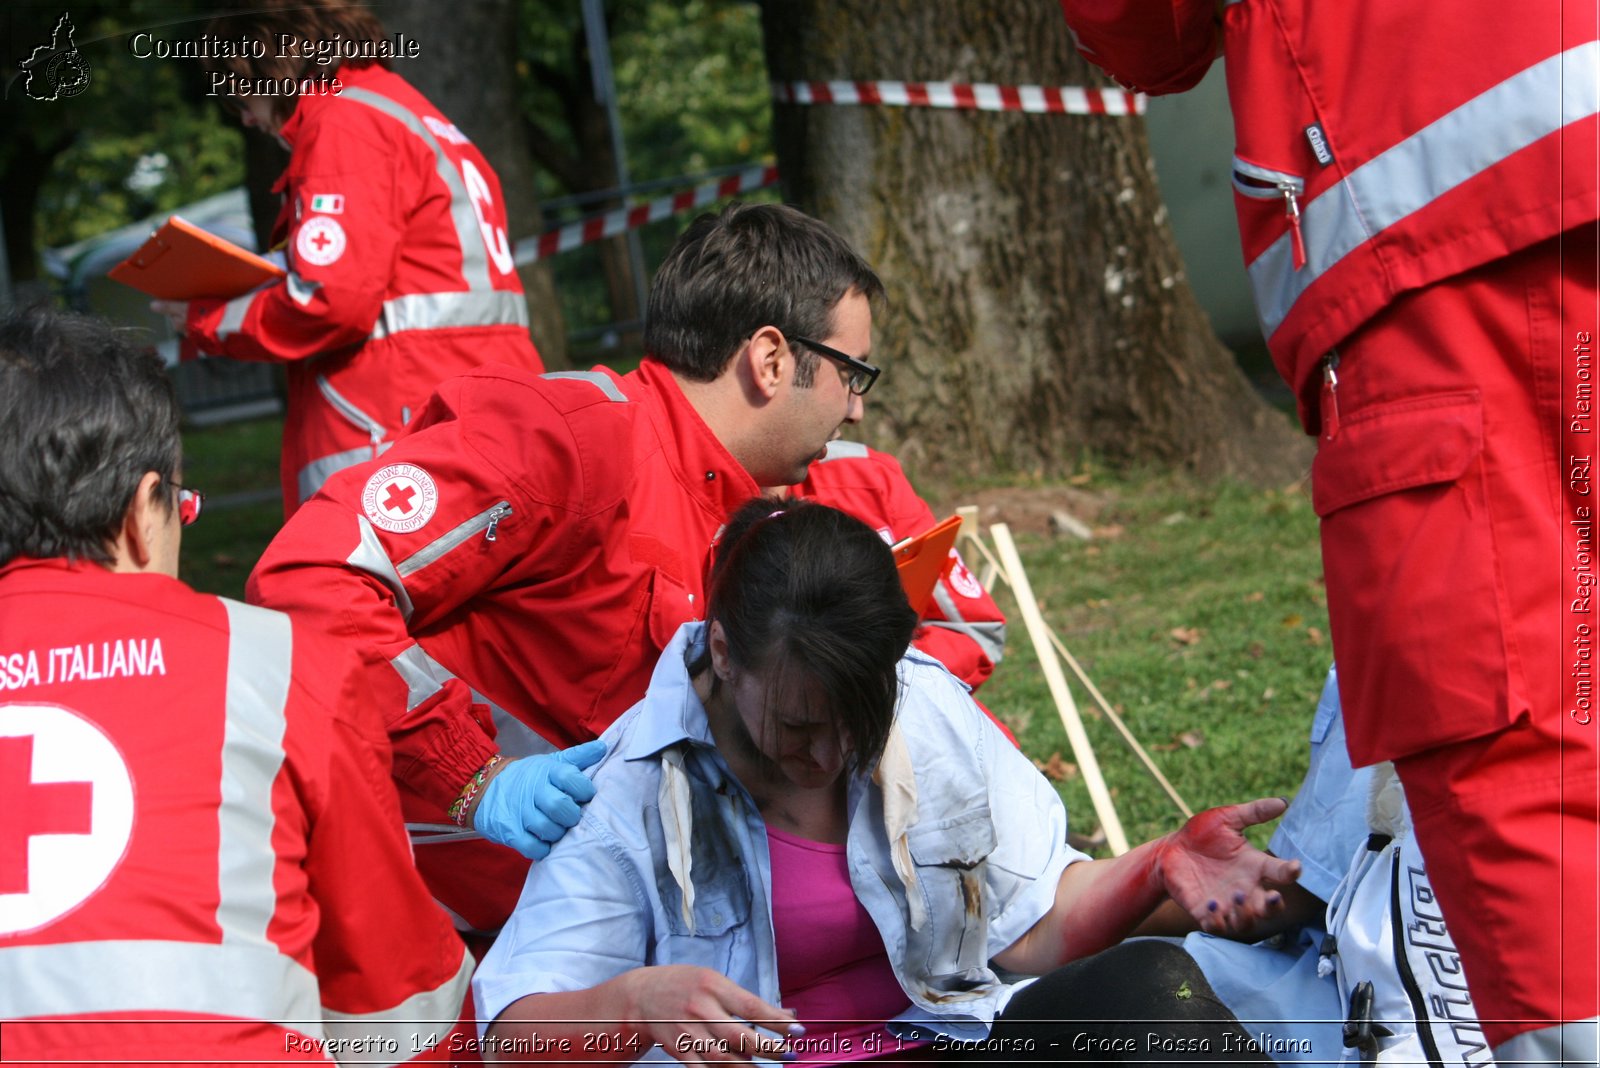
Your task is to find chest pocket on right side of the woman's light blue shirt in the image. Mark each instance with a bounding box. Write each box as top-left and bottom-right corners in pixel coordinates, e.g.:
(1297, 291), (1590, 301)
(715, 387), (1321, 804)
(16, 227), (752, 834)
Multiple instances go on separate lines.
(906, 806), (995, 991)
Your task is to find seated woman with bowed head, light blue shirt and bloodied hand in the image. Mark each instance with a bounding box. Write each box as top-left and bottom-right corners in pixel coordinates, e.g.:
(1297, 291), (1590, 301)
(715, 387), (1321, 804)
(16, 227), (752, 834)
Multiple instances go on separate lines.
(474, 499), (1298, 1062)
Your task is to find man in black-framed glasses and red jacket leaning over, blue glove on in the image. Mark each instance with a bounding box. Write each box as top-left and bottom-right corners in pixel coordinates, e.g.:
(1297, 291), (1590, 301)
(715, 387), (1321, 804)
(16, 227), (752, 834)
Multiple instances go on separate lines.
(250, 205), (883, 934)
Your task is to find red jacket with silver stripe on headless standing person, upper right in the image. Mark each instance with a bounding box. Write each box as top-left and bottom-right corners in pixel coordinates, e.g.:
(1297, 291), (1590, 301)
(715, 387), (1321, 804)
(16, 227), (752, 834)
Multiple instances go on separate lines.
(1062, 0), (1600, 430)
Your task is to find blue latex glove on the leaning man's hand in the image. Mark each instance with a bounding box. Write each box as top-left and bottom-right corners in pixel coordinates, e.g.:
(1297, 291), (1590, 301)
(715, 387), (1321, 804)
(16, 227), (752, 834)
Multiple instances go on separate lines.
(472, 739), (605, 860)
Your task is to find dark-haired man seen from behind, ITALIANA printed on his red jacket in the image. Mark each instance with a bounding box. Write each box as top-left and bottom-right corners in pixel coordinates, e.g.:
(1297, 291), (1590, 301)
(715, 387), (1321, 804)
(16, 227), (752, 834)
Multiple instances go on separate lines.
(0, 303), (472, 1063)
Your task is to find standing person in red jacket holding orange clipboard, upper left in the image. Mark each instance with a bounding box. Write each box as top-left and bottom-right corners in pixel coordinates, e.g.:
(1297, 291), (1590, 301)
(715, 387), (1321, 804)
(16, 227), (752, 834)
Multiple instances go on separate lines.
(154, 0), (544, 524)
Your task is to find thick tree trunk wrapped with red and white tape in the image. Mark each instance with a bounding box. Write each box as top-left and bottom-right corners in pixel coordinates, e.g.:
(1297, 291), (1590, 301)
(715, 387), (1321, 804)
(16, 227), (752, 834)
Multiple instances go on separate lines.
(763, 0), (1309, 481)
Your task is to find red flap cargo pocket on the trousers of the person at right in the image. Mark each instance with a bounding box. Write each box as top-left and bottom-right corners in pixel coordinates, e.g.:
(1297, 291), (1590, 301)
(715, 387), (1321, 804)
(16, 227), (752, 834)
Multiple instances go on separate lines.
(1312, 390), (1512, 766)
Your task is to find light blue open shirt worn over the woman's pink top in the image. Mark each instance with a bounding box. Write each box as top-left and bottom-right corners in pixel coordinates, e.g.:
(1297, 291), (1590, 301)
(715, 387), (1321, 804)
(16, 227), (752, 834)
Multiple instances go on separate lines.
(472, 624), (1086, 1038)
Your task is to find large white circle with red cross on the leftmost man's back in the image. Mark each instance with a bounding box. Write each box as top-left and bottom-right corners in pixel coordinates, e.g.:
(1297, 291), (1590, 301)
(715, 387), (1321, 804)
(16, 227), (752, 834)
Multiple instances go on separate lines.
(0, 705), (133, 934)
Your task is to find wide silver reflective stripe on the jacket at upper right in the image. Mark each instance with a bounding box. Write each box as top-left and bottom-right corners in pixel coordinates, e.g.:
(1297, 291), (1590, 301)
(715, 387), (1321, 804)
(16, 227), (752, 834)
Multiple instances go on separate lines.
(1250, 42), (1600, 337)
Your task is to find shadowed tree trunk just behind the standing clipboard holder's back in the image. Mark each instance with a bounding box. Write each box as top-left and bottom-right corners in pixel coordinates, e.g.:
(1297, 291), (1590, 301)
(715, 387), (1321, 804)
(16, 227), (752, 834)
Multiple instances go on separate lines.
(374, 0), (568, 369)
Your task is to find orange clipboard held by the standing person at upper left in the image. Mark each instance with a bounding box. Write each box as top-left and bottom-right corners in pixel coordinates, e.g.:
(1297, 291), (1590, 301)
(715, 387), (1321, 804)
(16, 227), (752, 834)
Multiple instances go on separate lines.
(106, 216), (283, 301)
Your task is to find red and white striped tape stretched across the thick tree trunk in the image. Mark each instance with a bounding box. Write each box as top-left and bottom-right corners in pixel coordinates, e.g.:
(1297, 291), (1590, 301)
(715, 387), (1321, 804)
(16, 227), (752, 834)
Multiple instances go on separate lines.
(773, 82), (1144, 115)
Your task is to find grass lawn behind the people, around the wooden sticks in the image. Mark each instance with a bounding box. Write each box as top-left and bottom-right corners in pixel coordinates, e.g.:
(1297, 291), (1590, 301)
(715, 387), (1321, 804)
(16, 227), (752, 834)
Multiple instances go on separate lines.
(184, 420), (1333, 843)
